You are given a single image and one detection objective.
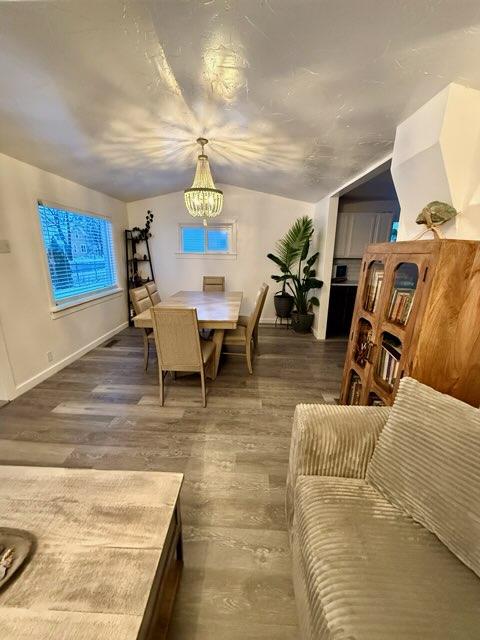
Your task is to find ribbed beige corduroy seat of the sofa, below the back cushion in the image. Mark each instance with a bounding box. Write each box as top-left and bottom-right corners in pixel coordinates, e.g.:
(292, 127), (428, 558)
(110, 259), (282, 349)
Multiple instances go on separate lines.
(293, 476), (480, 640)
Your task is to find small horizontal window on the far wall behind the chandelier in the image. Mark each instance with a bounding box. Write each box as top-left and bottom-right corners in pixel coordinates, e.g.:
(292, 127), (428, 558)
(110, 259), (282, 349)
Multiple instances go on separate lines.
(179, 223), (235, 255)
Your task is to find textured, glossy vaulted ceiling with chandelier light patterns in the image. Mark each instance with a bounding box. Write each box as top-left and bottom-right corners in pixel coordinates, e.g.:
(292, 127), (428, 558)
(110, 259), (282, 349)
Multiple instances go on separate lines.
(0, 0), (480, 201)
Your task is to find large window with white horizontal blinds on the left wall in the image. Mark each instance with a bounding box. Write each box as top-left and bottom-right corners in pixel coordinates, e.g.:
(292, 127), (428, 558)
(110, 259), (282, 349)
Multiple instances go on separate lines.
(38, 201), (117, 306)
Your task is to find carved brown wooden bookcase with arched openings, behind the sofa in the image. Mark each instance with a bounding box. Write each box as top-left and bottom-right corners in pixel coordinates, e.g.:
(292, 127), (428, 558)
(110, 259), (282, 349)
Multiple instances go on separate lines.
(340, 240), (480, 407)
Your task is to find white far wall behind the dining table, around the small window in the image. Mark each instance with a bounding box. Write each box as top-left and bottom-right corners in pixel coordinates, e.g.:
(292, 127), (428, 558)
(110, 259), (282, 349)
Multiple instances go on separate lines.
(127, 185), (314, 322)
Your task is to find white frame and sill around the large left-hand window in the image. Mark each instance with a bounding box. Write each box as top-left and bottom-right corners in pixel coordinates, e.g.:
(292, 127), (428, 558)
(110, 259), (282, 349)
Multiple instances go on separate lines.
(35, 198), (123, 312)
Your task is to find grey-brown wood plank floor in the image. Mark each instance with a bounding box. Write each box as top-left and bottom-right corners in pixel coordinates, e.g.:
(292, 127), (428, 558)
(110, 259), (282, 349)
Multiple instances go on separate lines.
(0, 328), (346, 640)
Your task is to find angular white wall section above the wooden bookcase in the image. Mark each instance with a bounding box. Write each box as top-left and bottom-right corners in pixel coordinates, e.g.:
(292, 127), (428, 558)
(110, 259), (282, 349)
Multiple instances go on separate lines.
(392, 84), (480, 240)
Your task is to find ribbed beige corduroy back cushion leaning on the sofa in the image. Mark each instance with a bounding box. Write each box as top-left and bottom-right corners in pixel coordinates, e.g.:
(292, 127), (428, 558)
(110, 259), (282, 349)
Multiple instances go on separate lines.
(367, 378), (480, 576)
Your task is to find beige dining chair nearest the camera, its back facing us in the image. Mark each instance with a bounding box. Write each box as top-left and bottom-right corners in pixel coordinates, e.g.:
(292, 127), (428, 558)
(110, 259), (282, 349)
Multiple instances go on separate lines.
(150, 307), (215, 407)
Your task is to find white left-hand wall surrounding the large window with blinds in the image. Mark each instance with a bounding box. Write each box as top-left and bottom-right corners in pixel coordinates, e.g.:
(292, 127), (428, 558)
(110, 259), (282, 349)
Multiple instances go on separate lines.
(0, 154), (127, 397)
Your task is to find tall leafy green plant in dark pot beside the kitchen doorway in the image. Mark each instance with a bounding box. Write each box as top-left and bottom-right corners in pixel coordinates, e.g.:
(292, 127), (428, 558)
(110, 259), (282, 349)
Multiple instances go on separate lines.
(267, 216), (323, 333)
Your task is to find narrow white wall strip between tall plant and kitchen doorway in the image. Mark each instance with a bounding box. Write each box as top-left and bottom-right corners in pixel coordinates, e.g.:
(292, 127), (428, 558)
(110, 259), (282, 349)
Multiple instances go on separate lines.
(313, 196), (338, 340)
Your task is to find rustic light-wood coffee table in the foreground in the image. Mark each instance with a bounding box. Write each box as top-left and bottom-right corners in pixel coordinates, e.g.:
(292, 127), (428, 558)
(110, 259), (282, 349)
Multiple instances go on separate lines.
(0, 466), (183, 640)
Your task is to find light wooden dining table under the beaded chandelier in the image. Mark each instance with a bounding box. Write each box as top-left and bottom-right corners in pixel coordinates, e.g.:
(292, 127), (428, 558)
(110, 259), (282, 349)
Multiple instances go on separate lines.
(133, 291), (243, 379)
